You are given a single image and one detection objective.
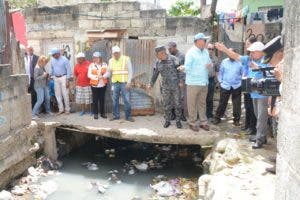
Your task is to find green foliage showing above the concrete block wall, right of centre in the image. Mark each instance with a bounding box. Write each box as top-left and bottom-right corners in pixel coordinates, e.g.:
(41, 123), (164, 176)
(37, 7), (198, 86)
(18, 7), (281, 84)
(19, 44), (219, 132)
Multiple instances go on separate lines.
(168, 0), (200, 16)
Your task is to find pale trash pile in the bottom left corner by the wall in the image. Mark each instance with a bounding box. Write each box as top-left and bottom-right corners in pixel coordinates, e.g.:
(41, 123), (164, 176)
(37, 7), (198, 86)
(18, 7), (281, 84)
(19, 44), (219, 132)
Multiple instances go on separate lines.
(4, 157), (62, 199)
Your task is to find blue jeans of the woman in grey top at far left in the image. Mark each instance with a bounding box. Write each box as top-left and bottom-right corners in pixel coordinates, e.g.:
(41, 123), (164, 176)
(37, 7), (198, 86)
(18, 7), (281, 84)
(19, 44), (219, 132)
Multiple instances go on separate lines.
(32, 86), (50, 116)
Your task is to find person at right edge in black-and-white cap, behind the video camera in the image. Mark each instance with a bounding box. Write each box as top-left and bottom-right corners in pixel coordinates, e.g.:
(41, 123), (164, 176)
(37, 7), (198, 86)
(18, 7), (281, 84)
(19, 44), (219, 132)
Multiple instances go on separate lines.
(263, 36), (284, 174)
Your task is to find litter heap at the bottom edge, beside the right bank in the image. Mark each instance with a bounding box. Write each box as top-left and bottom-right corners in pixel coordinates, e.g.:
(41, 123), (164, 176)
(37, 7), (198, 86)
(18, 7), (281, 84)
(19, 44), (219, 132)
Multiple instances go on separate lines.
(149, 175), (198, 200)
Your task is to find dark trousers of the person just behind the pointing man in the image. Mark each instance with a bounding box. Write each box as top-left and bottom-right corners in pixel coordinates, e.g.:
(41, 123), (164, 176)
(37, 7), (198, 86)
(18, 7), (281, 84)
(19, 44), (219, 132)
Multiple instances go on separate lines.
(244, 93), (256, 130)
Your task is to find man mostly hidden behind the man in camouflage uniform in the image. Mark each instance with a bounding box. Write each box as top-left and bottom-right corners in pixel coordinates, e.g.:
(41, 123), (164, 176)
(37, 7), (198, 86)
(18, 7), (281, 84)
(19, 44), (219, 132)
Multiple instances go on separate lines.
(168, 42), (187, 122)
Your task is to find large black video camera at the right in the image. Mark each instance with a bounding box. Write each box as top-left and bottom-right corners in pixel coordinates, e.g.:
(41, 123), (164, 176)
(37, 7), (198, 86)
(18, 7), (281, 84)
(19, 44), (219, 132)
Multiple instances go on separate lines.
(242, 67), (280, 96)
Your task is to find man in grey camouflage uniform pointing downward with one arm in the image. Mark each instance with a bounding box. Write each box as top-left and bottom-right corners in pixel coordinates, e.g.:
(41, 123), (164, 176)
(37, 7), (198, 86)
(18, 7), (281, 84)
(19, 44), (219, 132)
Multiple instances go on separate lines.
(148, 46), (182, 128)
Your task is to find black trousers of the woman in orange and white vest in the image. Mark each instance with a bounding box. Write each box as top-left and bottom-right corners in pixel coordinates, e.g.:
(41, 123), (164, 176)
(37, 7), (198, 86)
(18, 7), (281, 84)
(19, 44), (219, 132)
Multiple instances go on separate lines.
(92, 86), (106, 115)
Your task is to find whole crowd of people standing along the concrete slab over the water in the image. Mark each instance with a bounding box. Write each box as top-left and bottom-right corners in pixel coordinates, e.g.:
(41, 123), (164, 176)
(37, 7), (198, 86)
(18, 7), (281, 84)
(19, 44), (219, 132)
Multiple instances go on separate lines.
(25, 33), (283, 158)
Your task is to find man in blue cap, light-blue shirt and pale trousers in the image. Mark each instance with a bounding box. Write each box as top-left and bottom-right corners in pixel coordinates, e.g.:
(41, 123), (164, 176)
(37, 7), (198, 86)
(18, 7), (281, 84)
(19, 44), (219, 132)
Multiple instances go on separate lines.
(50, 48), (71, 114)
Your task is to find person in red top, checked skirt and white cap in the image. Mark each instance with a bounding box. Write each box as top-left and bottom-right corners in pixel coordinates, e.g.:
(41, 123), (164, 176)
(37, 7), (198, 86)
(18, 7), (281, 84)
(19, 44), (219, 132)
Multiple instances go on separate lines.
(74, 52), (92, 116)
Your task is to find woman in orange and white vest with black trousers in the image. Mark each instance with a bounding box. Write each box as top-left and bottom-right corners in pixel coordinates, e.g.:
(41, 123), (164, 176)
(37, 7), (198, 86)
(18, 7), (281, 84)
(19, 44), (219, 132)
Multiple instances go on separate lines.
(88, 51), (110, 119)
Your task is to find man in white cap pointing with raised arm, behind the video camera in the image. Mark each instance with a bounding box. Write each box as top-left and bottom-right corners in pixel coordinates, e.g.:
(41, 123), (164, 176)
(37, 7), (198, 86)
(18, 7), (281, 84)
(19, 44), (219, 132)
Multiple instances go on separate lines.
(215, 42), (268, 149)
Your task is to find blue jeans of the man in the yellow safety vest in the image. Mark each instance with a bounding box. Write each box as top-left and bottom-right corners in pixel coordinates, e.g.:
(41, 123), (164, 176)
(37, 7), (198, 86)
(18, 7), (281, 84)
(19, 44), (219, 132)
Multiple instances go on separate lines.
(112, 83), (131, 119)
